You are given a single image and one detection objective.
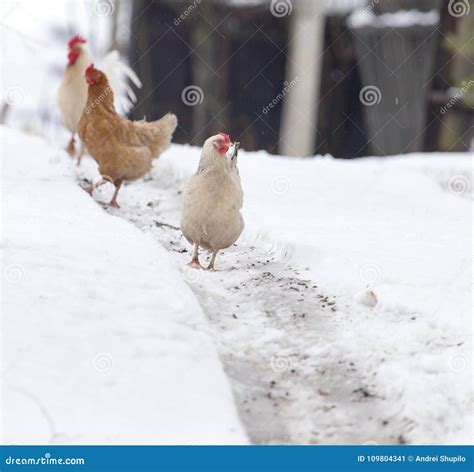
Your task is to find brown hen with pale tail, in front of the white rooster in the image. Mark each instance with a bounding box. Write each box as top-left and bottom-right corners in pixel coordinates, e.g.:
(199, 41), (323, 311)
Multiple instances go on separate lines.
(78, 64), (178, 208)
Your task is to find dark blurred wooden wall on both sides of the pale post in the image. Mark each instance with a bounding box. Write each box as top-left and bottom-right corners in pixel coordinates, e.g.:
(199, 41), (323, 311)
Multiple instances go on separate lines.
(125, 0), (474, 158)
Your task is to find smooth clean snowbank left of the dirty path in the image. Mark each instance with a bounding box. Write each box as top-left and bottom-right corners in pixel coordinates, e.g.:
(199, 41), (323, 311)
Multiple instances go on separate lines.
(1, 127), (247, 444)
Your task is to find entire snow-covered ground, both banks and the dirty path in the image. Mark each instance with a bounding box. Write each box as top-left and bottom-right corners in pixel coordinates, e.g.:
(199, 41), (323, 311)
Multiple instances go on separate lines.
(2, 123), (472, 444)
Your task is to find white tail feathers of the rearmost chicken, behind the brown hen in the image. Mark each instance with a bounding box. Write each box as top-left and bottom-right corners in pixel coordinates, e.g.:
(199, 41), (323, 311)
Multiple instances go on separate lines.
(102, 50), (142, 114)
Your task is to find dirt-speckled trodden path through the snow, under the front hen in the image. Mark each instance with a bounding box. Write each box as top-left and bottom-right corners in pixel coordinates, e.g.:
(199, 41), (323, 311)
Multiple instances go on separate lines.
(77, 170), (412, 444)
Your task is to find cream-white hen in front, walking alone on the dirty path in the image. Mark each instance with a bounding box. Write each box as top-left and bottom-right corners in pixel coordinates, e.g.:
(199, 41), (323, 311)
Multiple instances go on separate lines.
(181, 133), (244, 270)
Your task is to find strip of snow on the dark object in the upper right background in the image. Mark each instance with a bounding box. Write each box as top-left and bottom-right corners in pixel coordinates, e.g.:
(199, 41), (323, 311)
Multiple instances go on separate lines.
(347, 8), (439, 28)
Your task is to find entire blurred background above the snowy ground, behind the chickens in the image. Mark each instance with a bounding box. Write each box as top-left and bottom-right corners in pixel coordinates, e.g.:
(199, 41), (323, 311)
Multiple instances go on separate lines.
(0, 0), (474, 158)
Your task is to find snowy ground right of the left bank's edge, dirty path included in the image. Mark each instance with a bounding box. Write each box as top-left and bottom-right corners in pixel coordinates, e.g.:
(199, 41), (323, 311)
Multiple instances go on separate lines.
(71, 141), (472, 444)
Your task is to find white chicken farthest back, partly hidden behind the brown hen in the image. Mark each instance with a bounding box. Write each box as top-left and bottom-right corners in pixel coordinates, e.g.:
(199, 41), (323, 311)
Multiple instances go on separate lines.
(58, 36), (142, 164)
